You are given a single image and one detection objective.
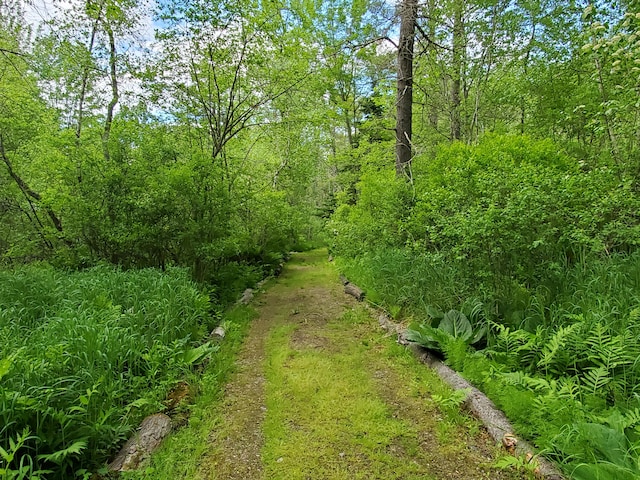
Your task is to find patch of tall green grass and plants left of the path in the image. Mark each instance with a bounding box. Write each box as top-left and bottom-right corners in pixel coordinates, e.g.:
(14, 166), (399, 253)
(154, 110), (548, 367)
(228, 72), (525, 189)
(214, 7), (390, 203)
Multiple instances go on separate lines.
(0, 266), (217, 478)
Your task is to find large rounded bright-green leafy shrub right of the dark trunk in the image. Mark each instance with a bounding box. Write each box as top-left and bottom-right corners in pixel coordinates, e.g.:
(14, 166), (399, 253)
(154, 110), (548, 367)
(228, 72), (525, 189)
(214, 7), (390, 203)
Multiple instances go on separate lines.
(407, 136), (640, 283)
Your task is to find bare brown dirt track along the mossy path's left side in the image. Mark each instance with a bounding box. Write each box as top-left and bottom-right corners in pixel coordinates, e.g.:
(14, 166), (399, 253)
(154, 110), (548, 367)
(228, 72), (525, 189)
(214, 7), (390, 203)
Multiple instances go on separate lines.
(198, 254), (355, 480)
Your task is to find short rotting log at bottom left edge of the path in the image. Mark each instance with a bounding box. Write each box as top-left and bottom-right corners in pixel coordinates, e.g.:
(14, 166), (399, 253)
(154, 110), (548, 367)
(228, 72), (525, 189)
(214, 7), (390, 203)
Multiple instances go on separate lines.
(109, 413), (171, 472)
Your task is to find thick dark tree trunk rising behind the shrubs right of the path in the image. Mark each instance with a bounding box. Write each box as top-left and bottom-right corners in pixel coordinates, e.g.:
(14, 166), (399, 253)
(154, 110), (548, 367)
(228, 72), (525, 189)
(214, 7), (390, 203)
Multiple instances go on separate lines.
(396, 0), (418, 178)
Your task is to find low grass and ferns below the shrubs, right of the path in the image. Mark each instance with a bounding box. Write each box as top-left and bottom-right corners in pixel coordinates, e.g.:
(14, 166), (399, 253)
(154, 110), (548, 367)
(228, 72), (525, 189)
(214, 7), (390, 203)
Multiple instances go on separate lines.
(339, 249), (640, 474)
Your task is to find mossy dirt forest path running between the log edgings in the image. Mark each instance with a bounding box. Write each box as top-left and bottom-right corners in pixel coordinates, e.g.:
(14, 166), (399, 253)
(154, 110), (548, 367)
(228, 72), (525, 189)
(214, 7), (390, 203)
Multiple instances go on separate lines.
(196, 250), (520, 480)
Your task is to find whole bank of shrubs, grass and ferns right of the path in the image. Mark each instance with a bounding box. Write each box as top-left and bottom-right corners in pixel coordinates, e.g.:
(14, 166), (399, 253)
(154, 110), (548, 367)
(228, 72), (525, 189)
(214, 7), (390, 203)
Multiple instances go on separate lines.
(329, 136), (640, 480)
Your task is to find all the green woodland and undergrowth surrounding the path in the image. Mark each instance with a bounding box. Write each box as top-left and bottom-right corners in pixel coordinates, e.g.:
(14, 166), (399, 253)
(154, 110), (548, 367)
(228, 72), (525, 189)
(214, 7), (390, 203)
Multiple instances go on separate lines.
(0, 0), (640, 479)
